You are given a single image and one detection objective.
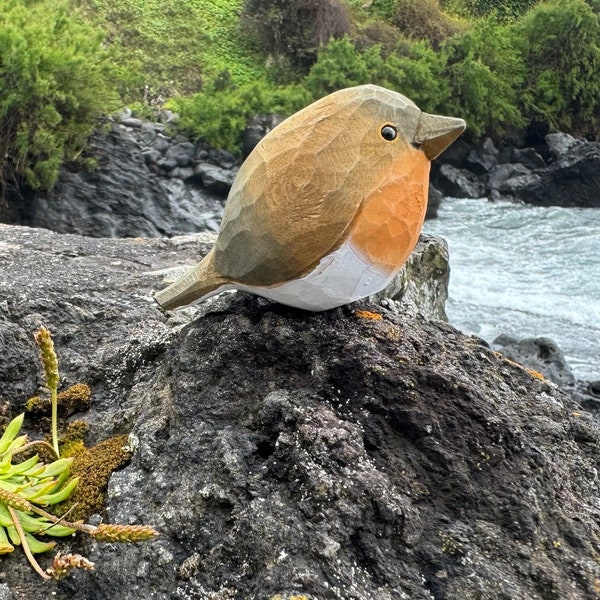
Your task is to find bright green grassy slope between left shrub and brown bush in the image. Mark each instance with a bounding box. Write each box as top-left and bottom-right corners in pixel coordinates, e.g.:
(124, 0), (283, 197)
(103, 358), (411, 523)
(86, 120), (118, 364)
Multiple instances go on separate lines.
(71, 0), (265, 101)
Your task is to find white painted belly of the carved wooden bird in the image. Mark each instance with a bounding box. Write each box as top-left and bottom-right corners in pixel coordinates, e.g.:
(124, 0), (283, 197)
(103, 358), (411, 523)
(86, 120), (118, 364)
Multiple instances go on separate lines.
(237, 242), (395, 311)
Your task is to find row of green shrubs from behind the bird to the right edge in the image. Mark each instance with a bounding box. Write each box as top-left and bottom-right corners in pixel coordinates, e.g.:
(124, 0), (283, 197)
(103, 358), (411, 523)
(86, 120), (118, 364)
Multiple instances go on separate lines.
(161, 0), (600, 149)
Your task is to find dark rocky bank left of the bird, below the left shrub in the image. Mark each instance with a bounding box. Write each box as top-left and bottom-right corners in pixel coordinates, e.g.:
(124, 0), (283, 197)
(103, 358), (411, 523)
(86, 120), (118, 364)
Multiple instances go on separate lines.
(5, 127), (223, 237)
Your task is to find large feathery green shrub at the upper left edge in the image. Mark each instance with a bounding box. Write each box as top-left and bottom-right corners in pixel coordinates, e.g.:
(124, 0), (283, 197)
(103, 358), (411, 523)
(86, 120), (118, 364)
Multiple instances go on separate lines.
(0, 0), (117, 190)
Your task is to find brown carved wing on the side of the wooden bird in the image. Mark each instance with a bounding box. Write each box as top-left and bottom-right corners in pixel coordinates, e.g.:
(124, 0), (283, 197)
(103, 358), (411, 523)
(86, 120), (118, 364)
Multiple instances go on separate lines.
(214, 106), (380, 286)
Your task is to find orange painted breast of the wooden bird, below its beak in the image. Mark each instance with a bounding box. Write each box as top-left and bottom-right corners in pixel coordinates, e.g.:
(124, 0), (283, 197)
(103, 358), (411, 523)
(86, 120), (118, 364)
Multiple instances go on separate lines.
(348, 148), (431, 274)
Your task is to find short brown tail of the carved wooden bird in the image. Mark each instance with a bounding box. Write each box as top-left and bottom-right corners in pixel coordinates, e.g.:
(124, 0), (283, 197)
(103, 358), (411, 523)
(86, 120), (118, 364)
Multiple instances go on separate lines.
(154, 251), (228, 310)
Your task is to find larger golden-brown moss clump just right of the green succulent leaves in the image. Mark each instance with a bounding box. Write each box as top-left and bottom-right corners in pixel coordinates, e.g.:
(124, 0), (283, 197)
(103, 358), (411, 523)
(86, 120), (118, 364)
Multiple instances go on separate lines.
(55, 432), (131, 521)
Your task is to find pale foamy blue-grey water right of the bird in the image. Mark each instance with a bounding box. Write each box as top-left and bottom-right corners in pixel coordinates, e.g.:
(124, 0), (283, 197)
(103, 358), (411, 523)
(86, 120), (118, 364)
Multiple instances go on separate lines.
(424, 198), (600, 380)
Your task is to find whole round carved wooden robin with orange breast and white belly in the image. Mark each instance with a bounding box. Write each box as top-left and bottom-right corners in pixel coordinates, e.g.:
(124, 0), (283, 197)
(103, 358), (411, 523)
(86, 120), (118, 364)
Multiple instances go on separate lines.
(156, 85), (465, 311)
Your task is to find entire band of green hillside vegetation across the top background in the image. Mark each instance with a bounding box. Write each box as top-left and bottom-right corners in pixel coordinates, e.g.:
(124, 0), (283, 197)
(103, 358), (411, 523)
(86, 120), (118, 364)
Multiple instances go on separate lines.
(0, 0), (600, 189)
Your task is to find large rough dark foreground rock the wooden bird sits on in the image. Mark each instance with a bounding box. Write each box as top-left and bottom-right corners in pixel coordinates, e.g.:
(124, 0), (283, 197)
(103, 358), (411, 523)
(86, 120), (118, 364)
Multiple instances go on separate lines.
(0, 227), (600, 600)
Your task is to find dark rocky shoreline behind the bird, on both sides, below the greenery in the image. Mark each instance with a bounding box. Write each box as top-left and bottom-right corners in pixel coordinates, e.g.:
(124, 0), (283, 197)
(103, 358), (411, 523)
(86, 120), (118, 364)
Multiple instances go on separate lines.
(3, 111), (600, 237)
